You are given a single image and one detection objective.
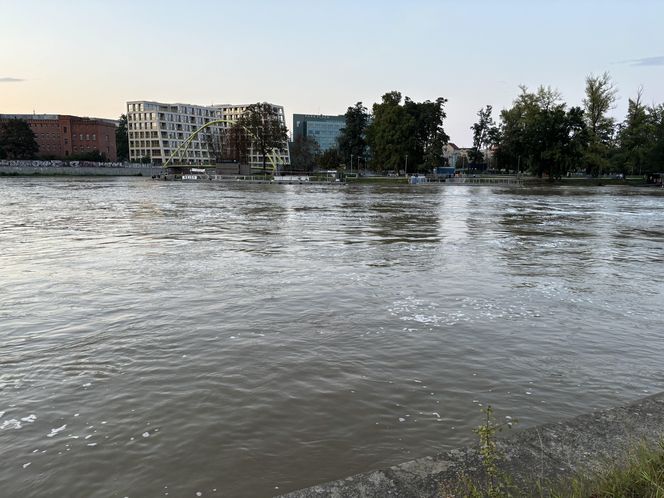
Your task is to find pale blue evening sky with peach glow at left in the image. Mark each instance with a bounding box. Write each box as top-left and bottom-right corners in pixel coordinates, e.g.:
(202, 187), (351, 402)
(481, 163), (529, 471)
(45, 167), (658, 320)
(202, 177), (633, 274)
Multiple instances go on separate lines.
(0, 0), (664, 147)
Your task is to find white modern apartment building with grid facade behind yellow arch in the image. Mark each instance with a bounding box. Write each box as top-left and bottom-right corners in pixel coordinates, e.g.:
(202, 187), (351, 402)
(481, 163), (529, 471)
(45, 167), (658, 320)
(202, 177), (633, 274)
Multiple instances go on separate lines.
(127, 100), (290, 169)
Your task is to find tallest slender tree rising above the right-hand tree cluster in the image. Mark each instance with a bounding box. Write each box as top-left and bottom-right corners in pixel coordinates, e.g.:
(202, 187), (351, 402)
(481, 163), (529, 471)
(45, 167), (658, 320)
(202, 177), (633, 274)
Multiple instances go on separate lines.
(583, 73), (617, 175)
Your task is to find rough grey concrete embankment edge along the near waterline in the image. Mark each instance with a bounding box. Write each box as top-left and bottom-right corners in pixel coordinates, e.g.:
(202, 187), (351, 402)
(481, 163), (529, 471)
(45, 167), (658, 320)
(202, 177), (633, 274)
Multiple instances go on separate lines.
(283, 393), (664, 498)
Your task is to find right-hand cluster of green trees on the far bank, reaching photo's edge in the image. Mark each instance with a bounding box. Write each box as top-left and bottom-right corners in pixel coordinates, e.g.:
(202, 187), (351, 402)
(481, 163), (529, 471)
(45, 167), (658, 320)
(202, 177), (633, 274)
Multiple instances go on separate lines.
(471, 73), (664, 178)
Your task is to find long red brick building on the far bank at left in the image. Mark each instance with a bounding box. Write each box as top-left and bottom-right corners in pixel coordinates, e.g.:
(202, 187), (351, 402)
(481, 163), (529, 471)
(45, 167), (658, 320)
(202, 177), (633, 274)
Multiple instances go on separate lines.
(0, 114), (118, 161)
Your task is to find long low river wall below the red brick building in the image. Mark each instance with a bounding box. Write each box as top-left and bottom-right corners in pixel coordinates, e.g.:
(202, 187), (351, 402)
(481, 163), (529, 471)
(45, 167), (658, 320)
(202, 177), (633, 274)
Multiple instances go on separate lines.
(0, 161), (164, 177)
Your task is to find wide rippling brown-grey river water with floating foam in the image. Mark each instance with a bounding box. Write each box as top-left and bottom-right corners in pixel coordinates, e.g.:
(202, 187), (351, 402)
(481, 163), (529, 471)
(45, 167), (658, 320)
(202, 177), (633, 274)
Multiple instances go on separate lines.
(0, 179), (664, 497)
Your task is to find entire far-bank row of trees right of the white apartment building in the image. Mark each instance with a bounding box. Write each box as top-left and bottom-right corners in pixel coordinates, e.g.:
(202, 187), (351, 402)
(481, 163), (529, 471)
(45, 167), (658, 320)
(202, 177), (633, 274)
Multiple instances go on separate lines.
(291, 73), (664, 179)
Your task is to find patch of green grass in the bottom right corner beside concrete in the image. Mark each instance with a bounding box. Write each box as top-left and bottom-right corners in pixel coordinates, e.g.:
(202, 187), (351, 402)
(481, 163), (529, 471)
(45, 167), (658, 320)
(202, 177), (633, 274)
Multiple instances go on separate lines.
(550, 438), (664, 498)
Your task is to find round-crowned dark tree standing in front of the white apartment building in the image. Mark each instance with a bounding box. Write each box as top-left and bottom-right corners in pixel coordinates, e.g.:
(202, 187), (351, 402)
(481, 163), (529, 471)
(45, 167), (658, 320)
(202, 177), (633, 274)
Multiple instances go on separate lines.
(237, 102), (288, 173)
